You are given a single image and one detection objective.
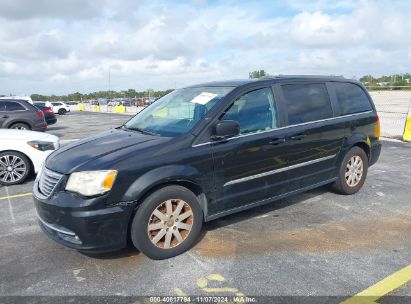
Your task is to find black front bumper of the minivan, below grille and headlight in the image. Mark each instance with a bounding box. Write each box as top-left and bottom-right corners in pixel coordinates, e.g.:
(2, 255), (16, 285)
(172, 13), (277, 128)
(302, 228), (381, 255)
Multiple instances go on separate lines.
(33, 184), (133, 253)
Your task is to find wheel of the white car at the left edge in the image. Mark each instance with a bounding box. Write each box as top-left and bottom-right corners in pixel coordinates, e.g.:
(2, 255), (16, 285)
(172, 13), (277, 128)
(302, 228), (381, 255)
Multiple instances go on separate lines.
(0, 151), (31, 186)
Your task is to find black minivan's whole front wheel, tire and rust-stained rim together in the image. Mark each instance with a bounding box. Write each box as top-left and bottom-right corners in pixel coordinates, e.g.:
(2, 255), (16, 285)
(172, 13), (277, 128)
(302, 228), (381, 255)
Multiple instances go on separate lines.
(131, 186), (203, 260)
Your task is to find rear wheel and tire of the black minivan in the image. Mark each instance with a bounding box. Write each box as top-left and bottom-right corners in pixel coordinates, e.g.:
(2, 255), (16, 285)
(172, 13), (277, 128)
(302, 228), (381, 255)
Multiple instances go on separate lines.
(333, 147), (368, 195)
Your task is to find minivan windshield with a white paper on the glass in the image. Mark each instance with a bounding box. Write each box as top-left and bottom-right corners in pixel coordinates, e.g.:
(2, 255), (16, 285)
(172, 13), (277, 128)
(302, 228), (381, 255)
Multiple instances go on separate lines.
(123, 87), (234, 137)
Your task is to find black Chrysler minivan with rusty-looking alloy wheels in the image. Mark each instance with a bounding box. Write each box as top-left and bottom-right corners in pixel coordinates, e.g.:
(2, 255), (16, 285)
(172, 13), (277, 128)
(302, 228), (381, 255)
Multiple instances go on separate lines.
(33, 76), (381, 259)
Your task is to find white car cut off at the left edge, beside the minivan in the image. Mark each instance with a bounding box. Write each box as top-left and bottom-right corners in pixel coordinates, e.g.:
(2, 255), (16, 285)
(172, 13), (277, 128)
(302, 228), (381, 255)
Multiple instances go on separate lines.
(0, 129), (60, 186)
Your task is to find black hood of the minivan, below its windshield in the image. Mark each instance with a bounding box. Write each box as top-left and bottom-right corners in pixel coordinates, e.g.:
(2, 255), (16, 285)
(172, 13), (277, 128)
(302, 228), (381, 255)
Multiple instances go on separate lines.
(46, 129), (170, 174)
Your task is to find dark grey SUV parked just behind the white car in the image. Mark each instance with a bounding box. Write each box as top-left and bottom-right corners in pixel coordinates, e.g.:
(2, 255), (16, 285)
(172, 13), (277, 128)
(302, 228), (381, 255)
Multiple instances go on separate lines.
(0, 99), (47, 131)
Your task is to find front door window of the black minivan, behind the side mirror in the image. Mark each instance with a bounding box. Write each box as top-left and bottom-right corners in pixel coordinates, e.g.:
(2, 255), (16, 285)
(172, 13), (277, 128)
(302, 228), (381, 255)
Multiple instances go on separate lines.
(222, 88), (277, 134)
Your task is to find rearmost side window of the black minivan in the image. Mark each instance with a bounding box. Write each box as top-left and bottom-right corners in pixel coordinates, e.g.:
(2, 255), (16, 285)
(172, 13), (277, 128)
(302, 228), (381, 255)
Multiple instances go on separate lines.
(333, 82), (372, 115)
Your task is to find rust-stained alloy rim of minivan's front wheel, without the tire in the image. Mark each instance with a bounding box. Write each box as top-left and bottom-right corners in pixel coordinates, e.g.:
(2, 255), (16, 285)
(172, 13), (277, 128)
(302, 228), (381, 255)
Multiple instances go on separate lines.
(147, 199), (194, 249)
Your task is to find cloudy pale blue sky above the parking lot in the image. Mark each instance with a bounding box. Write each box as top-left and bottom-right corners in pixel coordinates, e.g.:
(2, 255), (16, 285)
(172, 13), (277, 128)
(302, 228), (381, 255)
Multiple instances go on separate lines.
(0, 0), (411, 94)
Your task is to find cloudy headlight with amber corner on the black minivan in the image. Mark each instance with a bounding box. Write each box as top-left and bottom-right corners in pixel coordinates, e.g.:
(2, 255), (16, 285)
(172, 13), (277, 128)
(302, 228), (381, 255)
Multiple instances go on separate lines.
(66, 170), (117, 196)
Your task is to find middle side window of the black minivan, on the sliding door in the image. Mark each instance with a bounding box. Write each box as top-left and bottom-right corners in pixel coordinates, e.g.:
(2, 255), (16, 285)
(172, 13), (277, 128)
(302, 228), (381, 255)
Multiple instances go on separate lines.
(281, 83), (333, 125)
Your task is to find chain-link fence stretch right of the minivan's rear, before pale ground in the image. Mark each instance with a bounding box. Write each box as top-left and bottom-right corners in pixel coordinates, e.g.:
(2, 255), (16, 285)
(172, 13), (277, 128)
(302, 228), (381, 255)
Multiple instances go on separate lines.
(369, 87), (411, 139)
